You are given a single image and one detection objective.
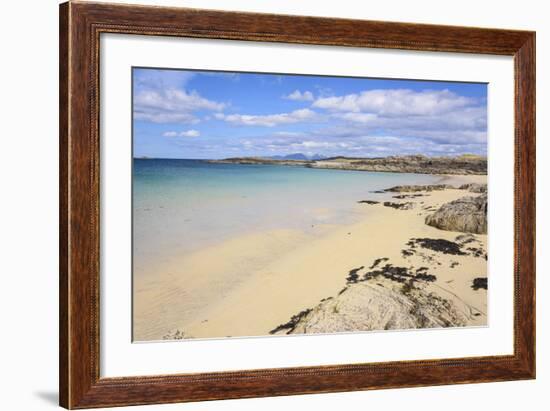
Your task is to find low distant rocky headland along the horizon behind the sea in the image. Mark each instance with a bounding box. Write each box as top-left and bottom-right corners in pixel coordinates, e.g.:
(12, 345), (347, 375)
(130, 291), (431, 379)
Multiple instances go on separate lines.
(210, 155), (487, 174)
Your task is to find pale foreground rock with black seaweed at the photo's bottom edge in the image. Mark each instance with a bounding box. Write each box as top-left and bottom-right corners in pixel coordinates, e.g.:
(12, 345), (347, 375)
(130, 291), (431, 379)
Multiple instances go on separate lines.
(270, 234), (487, 334)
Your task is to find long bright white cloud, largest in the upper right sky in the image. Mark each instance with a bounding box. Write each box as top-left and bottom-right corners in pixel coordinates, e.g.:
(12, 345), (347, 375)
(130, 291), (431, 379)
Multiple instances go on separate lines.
(313, 89), (475, 116)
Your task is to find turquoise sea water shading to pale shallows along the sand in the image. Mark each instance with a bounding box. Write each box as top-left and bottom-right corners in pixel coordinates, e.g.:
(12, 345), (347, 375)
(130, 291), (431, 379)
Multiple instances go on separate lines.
(133, 159), (439, 274)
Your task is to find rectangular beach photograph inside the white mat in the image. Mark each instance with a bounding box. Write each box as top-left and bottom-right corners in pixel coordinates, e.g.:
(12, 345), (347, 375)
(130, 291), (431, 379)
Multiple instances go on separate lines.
(132, 67), (489, 342)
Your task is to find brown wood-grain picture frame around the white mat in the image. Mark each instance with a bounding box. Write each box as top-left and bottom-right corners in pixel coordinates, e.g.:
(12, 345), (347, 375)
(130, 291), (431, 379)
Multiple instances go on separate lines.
(59, 2), (535, 409)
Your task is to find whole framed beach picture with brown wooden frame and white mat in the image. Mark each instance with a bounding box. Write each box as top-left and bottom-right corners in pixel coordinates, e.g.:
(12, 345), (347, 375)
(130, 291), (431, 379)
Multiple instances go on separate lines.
(60, 2), (535, 409)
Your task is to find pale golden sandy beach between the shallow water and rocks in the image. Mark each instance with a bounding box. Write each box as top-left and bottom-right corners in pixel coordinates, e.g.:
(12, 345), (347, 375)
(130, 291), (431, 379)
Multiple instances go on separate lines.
(134, 175), (487, 341)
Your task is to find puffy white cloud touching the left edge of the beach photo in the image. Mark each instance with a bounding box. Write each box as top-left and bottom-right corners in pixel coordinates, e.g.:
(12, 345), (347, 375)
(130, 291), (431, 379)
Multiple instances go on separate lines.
(134, 88), (226, 124)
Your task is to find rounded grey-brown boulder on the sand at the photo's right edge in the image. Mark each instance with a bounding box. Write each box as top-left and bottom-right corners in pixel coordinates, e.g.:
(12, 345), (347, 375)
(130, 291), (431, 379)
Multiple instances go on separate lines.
(425, 194), (487, 234)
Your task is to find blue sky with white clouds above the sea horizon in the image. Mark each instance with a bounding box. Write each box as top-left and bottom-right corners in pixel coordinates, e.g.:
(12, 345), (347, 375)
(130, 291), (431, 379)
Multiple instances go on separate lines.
(133, 68), (487, 159)
